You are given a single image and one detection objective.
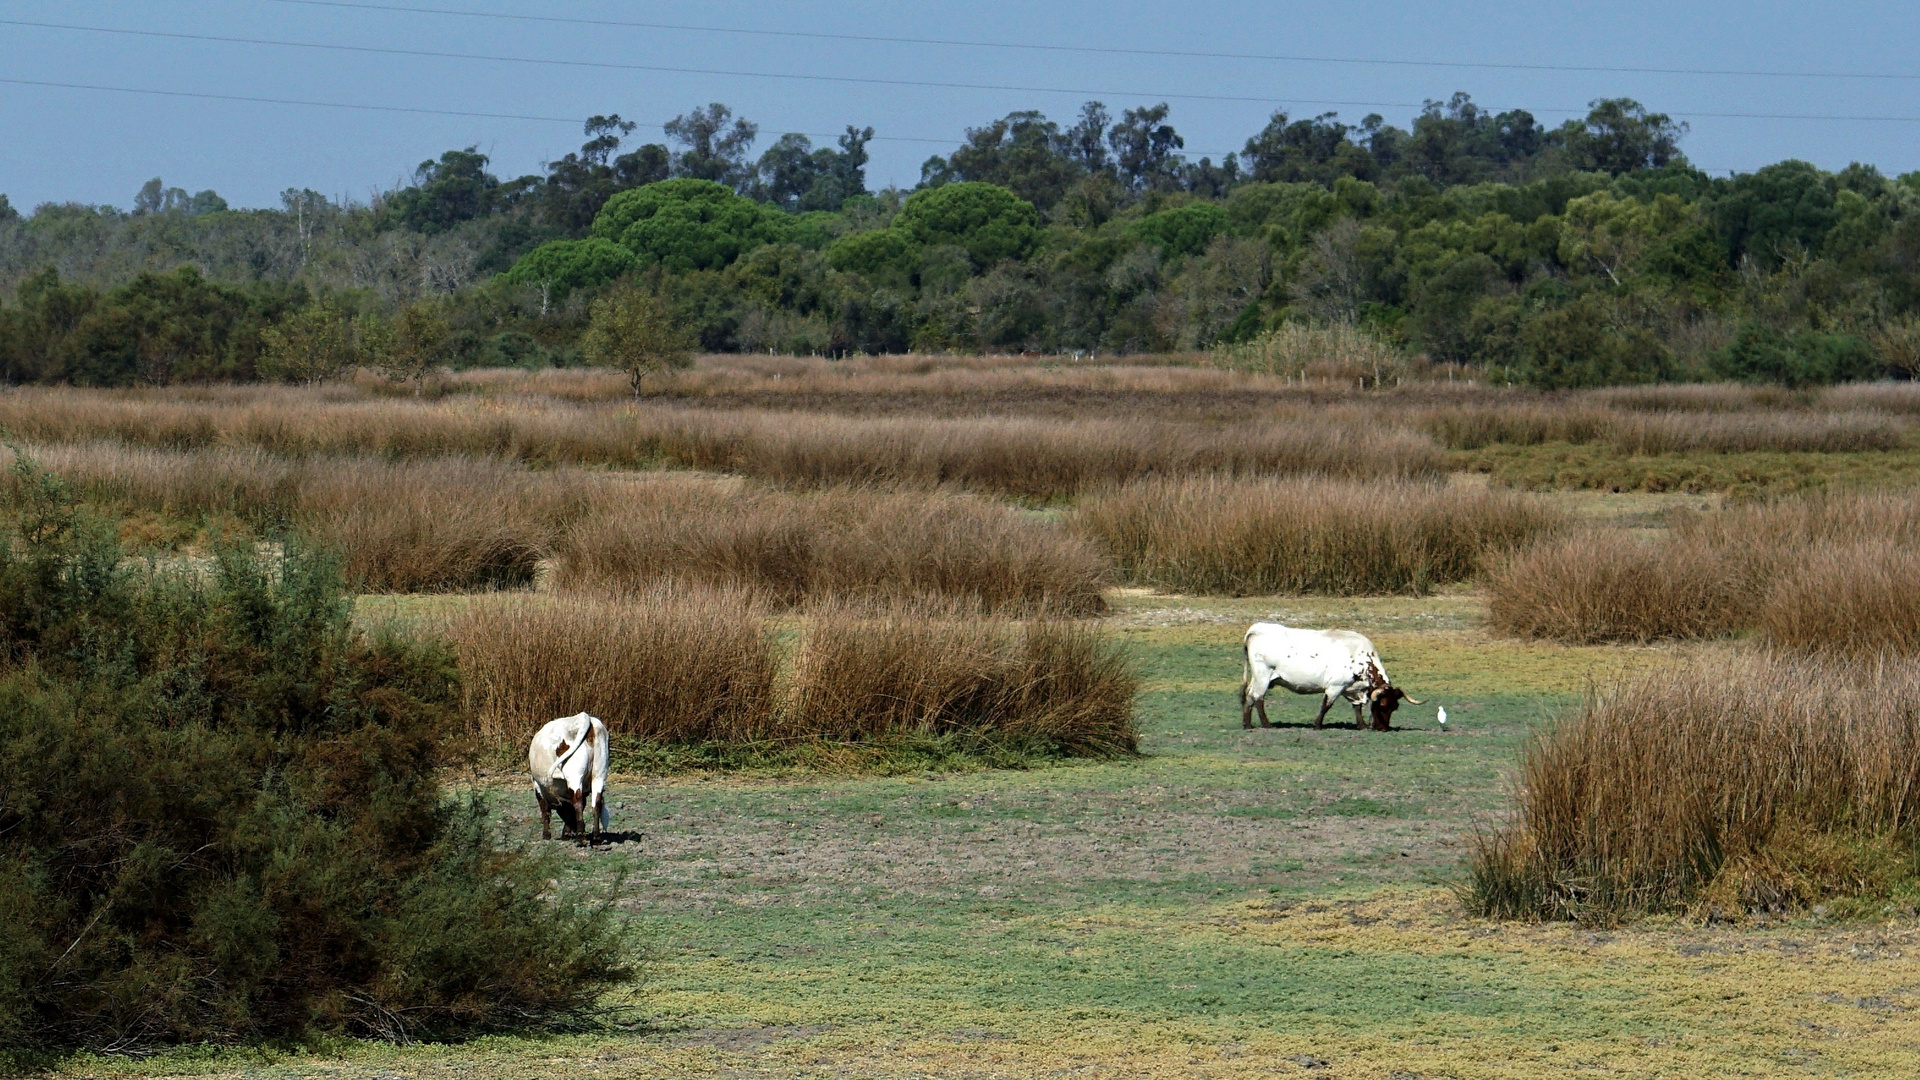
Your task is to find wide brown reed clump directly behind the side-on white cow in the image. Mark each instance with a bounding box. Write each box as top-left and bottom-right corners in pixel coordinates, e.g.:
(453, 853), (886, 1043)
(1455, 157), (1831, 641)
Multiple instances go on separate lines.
(1073, 479), (1567, 596)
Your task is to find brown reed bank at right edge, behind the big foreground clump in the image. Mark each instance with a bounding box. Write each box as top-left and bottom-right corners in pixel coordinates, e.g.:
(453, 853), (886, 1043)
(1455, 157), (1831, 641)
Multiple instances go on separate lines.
(1488, 492), (1920, 653)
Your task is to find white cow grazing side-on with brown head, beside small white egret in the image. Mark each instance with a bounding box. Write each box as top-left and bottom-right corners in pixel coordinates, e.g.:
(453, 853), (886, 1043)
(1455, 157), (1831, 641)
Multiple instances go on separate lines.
(1240, 623), (1421, 732)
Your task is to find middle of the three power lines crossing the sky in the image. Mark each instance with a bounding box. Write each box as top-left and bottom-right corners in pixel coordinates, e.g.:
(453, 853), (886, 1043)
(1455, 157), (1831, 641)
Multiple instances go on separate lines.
(11, 19), (1920, 123)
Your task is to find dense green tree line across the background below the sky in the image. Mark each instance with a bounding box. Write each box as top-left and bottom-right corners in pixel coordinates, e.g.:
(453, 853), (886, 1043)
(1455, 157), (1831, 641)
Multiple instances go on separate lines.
(0, 94), (1920, 386)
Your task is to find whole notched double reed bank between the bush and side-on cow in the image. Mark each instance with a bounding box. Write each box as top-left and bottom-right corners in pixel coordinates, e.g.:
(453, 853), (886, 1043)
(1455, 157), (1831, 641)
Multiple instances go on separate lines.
(444, 584), (1137, 755)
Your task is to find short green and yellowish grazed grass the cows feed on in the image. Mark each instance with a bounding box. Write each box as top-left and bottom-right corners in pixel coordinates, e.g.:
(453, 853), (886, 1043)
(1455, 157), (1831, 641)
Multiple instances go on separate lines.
(82, 592), (1920, 1078)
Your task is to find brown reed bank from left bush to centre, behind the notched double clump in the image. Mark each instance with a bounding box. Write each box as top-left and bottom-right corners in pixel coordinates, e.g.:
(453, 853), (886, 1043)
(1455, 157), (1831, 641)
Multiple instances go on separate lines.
(0, 442), (1108, 599)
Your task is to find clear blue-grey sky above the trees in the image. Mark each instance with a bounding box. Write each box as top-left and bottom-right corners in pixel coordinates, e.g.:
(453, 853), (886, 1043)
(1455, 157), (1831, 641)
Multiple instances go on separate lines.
(0, 0), (1920, 211)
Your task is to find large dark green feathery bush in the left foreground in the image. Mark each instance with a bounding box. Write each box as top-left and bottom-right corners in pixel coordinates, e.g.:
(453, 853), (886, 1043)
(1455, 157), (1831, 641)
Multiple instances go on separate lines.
(0, 463), (628, 1049)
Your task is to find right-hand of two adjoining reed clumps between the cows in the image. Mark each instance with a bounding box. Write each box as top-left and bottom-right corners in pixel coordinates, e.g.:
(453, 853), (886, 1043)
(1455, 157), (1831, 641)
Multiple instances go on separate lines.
(789, 603), (1139, 755)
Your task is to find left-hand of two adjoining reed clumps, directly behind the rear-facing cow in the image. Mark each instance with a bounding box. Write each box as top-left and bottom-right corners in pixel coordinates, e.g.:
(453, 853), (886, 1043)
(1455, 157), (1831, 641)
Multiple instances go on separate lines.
(445, 586), (778, 749)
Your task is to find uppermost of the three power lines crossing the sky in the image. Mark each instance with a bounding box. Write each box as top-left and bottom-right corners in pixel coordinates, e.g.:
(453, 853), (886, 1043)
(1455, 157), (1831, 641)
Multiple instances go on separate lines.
(259, 0), (1920, 81)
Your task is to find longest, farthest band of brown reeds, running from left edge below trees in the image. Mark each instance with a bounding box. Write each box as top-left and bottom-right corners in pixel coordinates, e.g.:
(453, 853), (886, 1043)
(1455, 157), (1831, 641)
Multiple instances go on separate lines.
(0, 390), (1446, 500)
